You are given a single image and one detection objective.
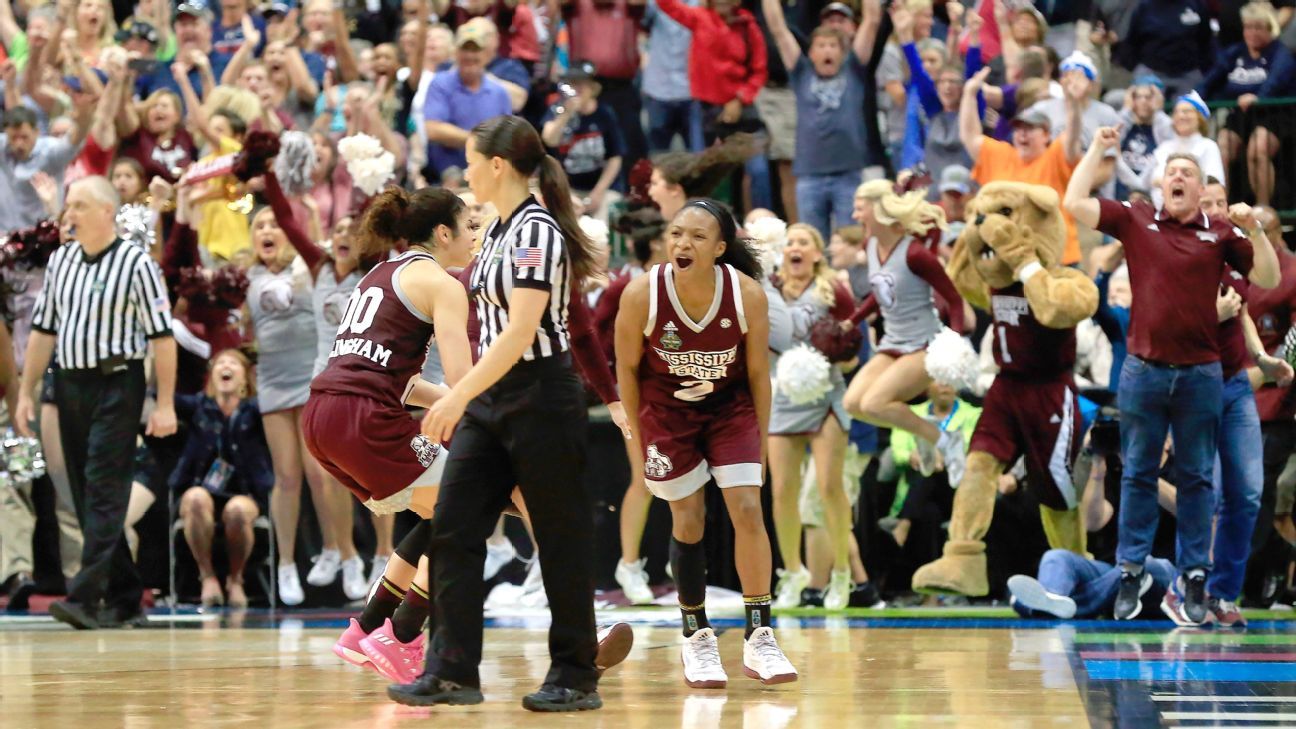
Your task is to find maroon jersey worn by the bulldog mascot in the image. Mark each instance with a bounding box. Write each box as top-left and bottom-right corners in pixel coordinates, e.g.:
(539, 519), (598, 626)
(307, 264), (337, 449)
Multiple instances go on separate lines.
(990, 283), (1076, 380)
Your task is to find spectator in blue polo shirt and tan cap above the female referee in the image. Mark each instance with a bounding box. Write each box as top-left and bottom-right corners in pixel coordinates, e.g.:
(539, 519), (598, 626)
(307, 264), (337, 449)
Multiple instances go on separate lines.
(422, 23), (513, 182)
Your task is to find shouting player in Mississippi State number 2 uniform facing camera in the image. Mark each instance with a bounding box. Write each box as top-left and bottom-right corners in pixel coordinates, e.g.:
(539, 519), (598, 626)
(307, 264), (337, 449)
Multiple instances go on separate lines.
(617, 200), (797, 689)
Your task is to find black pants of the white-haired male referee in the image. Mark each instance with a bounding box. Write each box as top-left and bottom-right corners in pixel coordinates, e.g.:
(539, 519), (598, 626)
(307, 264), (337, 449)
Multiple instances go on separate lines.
(54, 361), (145, 609)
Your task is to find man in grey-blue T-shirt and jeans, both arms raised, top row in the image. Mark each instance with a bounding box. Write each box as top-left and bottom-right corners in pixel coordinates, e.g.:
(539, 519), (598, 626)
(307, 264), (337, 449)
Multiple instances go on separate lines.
(762, 0), (881, 240)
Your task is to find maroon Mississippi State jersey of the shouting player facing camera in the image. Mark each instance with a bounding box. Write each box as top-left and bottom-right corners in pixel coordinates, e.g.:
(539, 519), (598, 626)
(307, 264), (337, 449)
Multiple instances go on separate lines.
(639, 263), (748, 407)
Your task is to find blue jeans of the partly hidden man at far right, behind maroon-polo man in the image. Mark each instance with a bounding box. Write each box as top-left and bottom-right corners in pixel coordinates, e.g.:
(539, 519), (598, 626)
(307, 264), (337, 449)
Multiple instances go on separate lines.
(1207, 370), (1265, 601)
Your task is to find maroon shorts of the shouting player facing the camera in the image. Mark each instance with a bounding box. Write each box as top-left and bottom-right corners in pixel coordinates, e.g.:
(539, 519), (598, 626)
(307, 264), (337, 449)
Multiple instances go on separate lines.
(639, 398), (763, 501)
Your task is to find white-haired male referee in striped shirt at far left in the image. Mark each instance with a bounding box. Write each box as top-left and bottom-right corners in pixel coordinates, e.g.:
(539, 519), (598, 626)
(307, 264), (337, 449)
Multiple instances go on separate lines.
(14, 176), (175, 629)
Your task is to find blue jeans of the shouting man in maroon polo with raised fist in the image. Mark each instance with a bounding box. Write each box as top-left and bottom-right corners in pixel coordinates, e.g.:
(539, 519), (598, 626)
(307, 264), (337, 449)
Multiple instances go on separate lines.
(1116, 354), (1218, 572)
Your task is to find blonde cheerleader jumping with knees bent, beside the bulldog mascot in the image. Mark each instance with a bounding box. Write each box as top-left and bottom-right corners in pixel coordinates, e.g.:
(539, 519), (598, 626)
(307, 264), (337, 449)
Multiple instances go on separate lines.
(845, 180), (966, 484)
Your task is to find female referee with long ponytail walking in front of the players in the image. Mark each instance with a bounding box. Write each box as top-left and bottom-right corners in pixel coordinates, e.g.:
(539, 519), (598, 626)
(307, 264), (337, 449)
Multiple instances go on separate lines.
(388, 117), (603, 711)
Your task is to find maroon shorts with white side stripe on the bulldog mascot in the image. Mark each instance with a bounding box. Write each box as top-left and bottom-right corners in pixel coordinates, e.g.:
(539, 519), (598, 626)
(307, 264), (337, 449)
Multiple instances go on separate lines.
(968, 375), (1083, 510)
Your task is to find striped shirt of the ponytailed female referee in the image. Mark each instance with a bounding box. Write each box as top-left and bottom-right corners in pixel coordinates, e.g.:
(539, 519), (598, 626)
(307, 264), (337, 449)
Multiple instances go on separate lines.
(472, 198), (572, 359)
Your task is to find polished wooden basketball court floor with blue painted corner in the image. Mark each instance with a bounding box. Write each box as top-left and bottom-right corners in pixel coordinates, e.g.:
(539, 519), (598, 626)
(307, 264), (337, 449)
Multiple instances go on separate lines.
(0, 608), (1296, 729)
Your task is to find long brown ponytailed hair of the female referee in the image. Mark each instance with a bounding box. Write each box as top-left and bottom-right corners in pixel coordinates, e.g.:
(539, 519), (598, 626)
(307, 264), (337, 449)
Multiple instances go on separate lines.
(472, 115), (596, 281)
